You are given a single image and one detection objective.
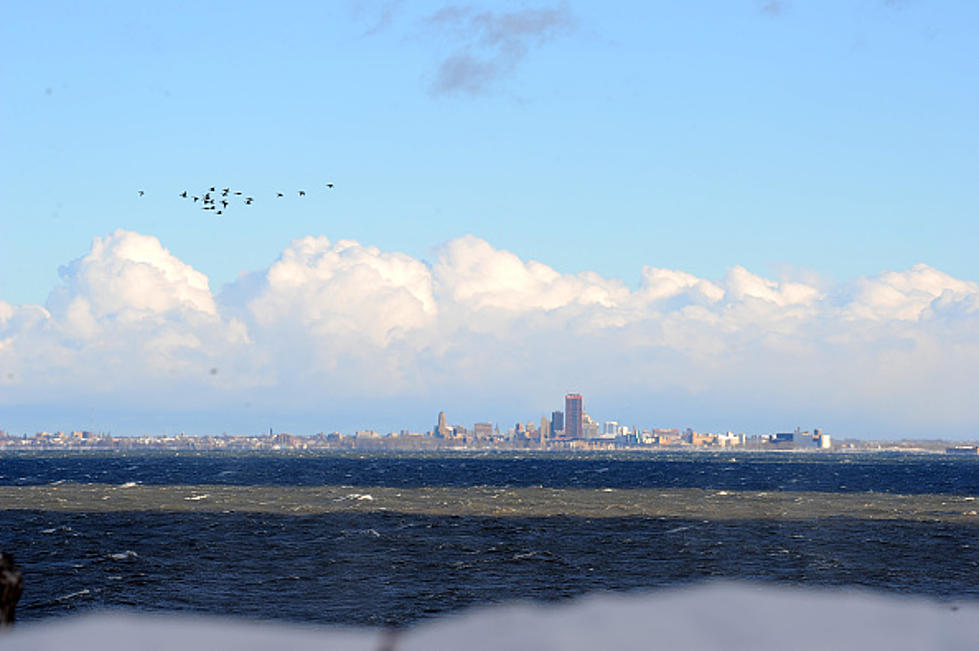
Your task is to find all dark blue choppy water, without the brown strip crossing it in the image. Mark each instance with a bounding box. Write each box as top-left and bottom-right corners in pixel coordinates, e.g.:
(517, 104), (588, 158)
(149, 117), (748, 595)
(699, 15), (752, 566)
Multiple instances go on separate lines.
(0, 453), (979, 625)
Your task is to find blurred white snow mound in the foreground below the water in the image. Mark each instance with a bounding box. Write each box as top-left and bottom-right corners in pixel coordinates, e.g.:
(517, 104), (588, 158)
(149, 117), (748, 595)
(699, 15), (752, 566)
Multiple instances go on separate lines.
(0, 584), (979, 651)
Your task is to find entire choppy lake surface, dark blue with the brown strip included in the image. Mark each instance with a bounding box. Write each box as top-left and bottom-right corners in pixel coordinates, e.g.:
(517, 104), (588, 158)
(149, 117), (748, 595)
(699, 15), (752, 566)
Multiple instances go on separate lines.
(0, 453), (979, 624)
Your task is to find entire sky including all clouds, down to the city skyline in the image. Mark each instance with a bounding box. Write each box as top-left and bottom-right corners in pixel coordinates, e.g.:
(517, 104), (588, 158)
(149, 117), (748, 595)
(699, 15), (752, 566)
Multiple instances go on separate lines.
(0, 0), (979, 439)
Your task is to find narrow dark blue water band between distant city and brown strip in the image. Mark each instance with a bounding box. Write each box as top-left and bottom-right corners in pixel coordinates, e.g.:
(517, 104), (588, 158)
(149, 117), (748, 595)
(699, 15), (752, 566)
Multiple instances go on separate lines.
(0, 452), (979, 494)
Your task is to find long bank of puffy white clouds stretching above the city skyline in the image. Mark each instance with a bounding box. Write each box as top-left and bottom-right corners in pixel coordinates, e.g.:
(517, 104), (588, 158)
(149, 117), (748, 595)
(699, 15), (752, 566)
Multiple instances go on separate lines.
(0, 230), (979, 437)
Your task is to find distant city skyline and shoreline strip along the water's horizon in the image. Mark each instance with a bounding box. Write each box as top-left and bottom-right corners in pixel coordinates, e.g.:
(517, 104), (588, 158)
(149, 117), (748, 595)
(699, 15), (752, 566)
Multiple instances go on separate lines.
(0, 393), (979, 455)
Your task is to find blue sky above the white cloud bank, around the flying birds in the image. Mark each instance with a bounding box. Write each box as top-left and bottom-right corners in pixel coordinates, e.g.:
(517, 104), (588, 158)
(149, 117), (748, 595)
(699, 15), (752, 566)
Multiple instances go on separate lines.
(0, 0), (979, 438)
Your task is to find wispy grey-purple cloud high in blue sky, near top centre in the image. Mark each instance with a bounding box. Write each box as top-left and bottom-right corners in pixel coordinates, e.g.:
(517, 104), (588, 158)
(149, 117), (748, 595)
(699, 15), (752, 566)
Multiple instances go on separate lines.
(427, 4), (574, 94)
